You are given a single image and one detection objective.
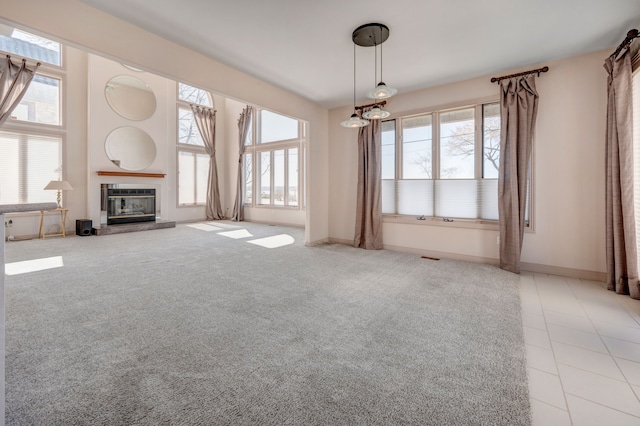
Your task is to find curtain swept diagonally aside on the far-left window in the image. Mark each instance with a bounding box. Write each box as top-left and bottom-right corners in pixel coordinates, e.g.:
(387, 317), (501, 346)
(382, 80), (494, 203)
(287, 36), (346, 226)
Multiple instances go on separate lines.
(0, 55), (40, 124)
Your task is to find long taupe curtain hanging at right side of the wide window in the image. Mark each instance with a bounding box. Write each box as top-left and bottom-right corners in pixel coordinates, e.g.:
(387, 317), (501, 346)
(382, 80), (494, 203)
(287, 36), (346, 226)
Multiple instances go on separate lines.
(498, 74), (538, 274)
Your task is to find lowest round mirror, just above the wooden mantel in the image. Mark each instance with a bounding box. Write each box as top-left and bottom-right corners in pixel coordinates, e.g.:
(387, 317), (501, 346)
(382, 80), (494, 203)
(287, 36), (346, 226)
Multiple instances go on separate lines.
(104, 127), (156, 170)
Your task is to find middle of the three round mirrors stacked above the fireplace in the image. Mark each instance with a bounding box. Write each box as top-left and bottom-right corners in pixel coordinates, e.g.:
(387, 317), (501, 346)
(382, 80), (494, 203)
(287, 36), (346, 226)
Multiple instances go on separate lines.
(104, 75), (156, 121)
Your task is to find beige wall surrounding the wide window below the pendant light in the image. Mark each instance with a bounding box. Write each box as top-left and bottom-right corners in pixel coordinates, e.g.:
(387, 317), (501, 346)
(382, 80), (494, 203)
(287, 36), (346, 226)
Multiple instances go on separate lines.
(329, 52), (607, 277)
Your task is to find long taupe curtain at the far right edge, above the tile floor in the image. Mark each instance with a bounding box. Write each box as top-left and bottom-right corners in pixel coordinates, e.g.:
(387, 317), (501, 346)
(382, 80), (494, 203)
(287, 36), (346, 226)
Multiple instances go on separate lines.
(604, 47), (640, 299)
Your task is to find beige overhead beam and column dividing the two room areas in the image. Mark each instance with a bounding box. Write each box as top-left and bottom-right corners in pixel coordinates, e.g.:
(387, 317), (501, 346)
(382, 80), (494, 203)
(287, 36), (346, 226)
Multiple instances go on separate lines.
(5, 0), (329, 242)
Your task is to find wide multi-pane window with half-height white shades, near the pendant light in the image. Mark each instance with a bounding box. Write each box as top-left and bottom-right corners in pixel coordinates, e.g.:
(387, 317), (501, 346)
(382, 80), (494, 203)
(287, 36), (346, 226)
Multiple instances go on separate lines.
(382, 103), (510, 221)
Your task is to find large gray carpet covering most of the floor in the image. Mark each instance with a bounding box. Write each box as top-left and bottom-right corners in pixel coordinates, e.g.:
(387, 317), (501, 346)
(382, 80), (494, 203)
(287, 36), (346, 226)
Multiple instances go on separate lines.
(6, 222), (530, 425)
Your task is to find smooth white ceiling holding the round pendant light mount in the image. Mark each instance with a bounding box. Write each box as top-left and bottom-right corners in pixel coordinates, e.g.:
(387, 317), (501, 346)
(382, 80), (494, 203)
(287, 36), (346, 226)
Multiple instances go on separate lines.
(81, 0), (640, 108)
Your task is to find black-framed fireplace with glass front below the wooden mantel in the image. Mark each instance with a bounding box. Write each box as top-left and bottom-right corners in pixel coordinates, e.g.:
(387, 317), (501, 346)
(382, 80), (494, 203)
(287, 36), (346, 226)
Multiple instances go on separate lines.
(106, 188), (156, 225)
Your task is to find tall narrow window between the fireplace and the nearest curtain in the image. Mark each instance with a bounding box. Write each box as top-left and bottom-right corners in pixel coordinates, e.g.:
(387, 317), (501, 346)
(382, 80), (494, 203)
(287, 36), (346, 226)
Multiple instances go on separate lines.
(177, 83), (213, 206)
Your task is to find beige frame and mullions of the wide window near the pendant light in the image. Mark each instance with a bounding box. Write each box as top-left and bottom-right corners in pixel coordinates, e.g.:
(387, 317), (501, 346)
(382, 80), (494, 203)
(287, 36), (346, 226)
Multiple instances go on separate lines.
(381, 96), (535, 232)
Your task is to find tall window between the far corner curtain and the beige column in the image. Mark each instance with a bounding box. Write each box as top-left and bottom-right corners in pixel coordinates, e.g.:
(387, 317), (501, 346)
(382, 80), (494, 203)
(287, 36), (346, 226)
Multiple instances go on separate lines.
(243, 109), (306, 208)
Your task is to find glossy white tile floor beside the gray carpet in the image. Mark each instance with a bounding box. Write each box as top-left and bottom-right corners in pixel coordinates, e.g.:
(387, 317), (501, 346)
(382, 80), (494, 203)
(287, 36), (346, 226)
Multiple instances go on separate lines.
(520, 272), (640, 426)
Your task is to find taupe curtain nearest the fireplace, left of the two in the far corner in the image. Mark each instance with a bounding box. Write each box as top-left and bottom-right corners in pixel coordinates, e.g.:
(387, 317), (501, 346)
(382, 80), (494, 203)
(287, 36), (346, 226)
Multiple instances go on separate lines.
(191, 105), (224, 220)
